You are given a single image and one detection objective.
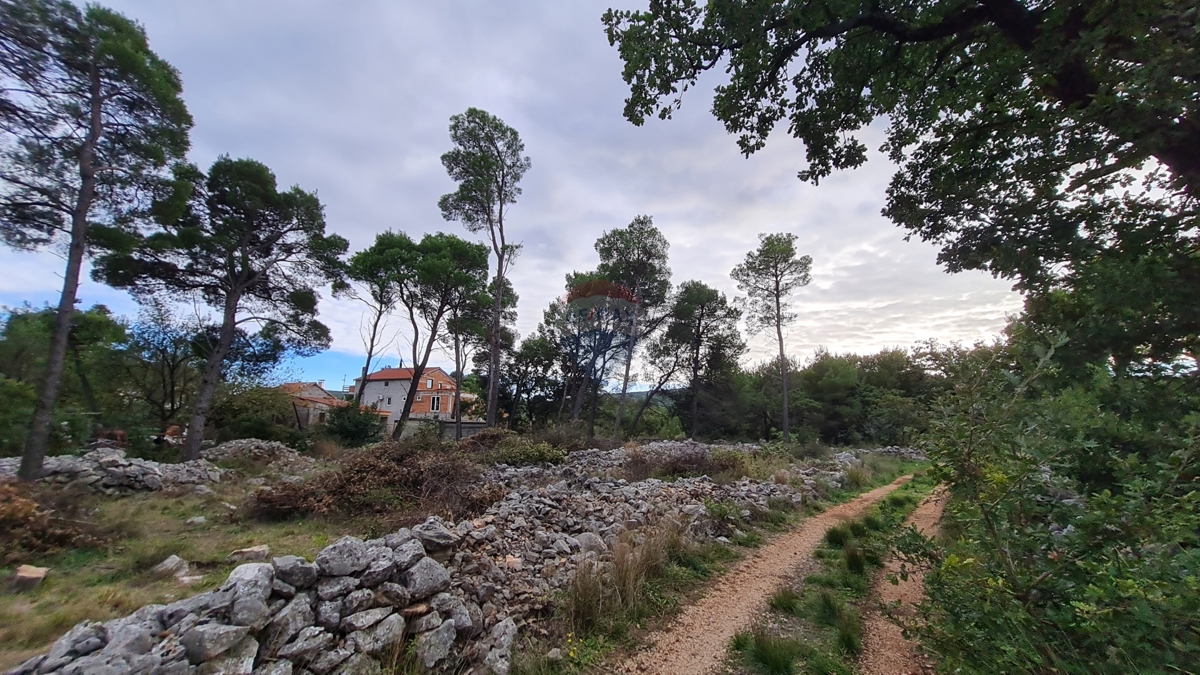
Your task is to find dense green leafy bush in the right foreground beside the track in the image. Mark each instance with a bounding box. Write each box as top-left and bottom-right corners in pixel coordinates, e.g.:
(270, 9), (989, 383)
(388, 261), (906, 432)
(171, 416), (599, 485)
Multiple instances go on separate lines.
(900, 348), (1200, 675)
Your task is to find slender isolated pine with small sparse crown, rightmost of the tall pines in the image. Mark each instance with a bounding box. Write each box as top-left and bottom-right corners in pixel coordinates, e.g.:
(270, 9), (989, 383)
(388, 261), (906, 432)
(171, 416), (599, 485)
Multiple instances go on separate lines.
(730, 233), (812, 443)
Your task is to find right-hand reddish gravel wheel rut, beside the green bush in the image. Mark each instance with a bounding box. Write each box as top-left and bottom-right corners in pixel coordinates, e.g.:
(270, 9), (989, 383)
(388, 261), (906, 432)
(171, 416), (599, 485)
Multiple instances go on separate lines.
(858, 490), (946, 675)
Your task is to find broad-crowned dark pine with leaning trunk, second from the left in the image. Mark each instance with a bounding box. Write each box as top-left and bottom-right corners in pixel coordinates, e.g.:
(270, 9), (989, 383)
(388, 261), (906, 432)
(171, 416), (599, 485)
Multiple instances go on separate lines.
(95, 156), (347, 460)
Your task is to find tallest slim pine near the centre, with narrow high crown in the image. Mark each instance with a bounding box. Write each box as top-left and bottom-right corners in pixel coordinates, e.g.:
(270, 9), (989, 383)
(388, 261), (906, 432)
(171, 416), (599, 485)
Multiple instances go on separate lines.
(438, 108), (530, 426)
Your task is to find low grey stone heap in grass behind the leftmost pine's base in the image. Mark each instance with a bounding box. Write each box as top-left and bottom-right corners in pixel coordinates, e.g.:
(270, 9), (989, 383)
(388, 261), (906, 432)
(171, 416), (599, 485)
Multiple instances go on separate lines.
(0, 448), (223, 495)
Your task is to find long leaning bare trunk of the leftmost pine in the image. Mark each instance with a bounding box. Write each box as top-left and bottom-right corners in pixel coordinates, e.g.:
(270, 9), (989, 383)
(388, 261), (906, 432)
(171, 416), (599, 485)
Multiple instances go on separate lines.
(18, 66), (104, 480)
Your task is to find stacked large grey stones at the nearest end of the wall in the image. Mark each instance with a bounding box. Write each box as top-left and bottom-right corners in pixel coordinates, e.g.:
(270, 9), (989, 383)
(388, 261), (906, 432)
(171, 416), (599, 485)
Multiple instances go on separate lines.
(10, 519), (516, 675)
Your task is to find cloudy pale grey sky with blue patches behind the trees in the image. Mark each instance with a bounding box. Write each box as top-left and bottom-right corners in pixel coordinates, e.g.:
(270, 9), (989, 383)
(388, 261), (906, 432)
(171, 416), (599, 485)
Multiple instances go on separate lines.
(0, 0), (1021, 388)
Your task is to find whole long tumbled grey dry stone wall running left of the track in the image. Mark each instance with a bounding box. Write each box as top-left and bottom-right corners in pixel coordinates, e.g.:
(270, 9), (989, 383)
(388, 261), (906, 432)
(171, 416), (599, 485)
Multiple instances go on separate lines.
(8, 447), (916, 675)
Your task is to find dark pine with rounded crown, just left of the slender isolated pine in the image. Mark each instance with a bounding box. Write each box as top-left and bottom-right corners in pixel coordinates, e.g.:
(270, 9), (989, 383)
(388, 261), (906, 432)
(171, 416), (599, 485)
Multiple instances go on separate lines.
(666, 281), (745, 438)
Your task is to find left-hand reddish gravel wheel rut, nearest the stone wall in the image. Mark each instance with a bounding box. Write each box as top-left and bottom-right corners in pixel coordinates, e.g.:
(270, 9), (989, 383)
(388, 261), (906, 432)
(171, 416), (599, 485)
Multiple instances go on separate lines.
(617, 476), (910, 675)
